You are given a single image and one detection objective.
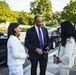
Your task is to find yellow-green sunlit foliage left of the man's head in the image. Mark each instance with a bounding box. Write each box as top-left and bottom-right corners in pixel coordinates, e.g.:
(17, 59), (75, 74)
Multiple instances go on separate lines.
(0, 1), (34, 25)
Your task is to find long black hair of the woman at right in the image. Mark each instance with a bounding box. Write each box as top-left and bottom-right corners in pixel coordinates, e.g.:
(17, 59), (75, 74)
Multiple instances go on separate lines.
(61, 21), (76, 46)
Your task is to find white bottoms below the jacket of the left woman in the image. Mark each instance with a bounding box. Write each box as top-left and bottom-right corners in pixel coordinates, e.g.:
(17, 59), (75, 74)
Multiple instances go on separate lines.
(8, 65), (23, 75)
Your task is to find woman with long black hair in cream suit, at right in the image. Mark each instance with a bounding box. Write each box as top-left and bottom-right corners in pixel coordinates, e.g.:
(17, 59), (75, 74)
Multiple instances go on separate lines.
(55, 21), (76, 75)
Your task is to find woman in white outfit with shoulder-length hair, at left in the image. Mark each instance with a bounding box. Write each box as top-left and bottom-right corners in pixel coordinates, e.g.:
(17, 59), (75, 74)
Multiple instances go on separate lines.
(7, 23), (29, 75)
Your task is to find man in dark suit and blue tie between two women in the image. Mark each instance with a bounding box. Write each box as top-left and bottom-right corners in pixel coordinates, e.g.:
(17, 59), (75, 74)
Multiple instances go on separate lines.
(25, 16), (50, 75)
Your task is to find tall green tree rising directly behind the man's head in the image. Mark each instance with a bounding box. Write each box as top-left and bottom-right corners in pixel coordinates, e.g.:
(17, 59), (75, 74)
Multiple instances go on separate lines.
(30, 0), (52, 23)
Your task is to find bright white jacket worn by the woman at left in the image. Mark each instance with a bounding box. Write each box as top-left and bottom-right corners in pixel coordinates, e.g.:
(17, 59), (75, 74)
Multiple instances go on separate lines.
(7, 35), (26, 65)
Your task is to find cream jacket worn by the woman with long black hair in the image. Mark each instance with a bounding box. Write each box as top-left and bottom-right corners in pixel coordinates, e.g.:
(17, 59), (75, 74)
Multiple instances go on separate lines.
(59, 37), (76, 68)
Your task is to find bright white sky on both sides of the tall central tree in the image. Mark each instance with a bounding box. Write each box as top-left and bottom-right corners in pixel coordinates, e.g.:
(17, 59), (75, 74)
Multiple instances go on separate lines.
(5, 0), (70, 12)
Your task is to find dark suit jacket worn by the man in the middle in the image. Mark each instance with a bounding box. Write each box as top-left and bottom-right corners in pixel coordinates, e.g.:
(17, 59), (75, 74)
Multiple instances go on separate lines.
(25, 26), (50, 60)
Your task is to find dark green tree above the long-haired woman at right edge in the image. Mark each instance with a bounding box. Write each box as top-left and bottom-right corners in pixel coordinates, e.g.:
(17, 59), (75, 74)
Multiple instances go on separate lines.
(62, 1), (76, 26)
